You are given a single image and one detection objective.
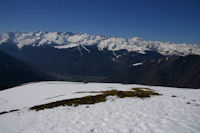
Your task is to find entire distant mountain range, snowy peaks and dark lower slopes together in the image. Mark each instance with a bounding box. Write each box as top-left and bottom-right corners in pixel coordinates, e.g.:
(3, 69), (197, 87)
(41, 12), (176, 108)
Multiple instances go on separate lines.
(0, 32), (200, 88)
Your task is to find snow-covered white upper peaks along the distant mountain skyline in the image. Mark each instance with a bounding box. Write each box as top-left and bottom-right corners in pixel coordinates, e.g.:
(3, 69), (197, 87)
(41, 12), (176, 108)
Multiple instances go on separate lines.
(0, 31), (200, 56)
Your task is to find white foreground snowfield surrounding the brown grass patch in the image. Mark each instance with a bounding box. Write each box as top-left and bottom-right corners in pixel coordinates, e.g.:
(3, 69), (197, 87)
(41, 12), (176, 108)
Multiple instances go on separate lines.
(0, 82), (200, 133)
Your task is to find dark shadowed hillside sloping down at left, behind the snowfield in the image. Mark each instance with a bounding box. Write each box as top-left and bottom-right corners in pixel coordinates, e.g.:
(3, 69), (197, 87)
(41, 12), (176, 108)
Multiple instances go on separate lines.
(0, 51), (53, 90)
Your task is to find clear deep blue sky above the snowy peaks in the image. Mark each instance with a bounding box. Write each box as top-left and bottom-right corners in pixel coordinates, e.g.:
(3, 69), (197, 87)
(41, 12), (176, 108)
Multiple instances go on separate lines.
(0, 0), (200, 44)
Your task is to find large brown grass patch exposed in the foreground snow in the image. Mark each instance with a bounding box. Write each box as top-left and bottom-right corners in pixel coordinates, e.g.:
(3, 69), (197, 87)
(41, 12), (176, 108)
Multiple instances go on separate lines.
(30, 88), (160, 111)
